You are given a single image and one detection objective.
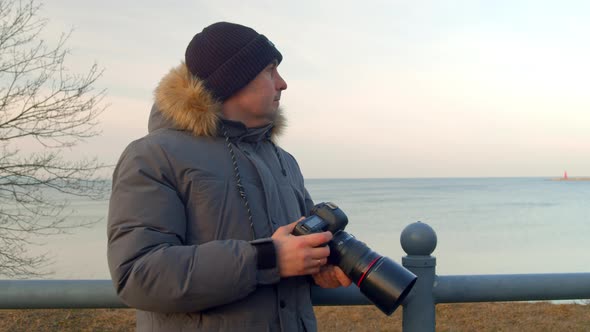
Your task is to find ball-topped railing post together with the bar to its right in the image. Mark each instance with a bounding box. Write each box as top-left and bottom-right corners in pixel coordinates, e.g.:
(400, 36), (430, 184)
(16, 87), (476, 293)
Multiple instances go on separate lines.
(401, 222), (590, 331)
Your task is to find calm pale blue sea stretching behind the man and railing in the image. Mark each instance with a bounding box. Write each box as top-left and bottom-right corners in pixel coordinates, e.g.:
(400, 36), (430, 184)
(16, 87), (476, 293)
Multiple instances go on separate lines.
(23, 178), (590, 279)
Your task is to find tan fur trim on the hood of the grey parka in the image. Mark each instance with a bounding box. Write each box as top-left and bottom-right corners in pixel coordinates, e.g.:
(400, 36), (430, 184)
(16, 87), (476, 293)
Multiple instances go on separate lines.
(148, 62), (286, 138)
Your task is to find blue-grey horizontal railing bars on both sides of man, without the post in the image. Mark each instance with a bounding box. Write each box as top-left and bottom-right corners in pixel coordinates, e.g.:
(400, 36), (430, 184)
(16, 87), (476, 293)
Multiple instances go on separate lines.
(0, 273), (590, 309)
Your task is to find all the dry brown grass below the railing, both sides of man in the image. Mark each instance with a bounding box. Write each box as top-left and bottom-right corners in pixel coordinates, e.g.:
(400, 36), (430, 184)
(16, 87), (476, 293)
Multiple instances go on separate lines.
(0, 303), (590, 332)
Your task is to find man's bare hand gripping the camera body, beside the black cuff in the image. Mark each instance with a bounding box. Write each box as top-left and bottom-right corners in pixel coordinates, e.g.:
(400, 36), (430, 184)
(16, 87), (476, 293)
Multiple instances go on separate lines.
(272, 217), (332, 277)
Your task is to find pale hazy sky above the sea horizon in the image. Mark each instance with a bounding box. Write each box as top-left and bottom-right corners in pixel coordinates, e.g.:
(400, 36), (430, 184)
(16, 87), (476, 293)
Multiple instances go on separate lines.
(31, 0), (590, 178)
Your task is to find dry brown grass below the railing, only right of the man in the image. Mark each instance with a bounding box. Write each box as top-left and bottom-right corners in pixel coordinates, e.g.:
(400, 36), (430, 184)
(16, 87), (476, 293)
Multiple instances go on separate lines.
(316, 303), (590, 332)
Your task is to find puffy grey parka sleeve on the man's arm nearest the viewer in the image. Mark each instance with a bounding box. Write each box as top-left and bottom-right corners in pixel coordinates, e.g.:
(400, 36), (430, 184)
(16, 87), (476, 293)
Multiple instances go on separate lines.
(107, 142), (280, 312)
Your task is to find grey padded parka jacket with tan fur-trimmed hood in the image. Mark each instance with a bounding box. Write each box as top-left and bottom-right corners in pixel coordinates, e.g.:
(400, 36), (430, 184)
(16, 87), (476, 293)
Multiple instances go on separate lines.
(108, 64), (316, 332)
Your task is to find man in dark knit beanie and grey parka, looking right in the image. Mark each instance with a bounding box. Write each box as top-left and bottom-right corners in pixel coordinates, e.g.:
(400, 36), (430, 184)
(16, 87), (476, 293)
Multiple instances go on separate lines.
(108, 22), (350, 331)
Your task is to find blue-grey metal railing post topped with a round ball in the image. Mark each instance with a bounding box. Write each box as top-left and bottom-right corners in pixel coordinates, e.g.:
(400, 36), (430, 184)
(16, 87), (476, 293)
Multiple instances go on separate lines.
(400, 221), (436, 332)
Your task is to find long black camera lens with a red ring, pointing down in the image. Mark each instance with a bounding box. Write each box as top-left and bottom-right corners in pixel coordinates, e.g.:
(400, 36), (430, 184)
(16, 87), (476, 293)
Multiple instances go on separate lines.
(329, 231), (417, 315)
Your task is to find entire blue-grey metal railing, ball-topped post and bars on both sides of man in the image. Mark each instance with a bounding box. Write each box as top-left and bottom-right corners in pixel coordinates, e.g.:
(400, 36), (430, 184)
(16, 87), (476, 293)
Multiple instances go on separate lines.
(0, 222), (590, 331)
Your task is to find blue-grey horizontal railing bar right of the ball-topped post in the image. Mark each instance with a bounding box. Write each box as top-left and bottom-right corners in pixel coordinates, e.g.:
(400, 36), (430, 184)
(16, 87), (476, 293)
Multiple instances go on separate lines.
(433, 273), (590, 303)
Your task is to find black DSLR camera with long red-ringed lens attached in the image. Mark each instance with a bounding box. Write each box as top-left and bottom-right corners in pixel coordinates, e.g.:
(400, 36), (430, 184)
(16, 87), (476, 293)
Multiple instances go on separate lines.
(293, 202), (417, 315)
